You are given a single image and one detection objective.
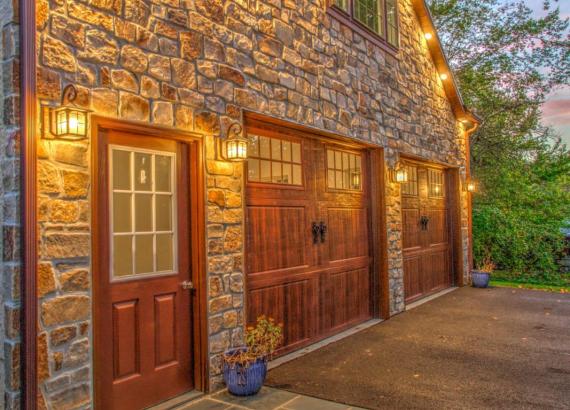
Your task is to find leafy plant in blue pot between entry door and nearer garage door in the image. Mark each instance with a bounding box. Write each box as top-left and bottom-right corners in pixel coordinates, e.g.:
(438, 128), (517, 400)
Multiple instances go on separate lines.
(223, 316), (283, 396)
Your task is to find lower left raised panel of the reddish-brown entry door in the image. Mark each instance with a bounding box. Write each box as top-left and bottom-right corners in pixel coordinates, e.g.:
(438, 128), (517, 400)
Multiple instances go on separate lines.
(113, 300), (140, 381)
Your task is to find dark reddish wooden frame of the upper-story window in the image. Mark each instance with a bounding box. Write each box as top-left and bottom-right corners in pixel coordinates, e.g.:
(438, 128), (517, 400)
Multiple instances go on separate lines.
(327, 0), (400, 55)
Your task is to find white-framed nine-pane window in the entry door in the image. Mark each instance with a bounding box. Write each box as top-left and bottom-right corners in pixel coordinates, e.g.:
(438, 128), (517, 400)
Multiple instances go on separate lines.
(109, 146), (177, 280)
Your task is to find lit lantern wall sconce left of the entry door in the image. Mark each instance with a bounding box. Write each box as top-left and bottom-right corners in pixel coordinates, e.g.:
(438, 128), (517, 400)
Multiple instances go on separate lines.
(42, 84), (89, 141)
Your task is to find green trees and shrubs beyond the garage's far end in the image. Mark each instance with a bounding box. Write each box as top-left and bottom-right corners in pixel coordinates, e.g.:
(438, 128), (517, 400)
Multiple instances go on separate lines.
(428, 0), (570, 281)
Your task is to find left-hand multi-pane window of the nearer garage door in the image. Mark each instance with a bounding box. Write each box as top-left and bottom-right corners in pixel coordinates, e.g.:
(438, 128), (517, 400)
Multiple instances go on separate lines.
(247, 135), (303, 185)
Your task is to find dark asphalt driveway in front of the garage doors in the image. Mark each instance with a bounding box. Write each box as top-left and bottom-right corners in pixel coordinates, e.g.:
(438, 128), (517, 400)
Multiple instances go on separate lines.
(267, 287), (570, 409)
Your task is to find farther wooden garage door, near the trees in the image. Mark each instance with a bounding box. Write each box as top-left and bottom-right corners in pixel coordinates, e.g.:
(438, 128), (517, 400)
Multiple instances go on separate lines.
(402, 163), (452, 303)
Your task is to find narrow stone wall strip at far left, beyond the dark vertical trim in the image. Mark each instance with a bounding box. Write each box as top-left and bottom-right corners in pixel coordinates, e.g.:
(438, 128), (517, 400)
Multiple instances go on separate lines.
(0, 0), (21, 409)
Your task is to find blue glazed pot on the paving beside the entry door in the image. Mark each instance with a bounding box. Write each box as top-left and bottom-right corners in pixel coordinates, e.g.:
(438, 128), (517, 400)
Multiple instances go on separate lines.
(223, 348), (267, 396)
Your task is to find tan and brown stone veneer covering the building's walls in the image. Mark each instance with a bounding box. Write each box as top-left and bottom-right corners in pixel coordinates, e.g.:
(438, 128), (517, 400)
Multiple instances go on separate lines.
(0, 0), (468, 409)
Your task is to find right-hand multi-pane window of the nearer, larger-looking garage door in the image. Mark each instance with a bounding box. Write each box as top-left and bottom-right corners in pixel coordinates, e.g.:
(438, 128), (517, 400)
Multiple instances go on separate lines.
(327, 148), (362, 191)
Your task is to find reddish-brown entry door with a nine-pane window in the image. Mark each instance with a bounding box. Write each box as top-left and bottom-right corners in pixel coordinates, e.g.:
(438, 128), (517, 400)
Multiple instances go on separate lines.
(94, 131), (194, 410)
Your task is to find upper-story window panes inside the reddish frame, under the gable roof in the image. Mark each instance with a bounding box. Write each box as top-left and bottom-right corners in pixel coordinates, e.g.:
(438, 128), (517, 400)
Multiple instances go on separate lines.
(333, 0), (399, 47)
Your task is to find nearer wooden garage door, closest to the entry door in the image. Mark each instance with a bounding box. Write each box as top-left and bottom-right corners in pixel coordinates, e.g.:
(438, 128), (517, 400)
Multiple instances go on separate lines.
(246, 122), (371, 353)
